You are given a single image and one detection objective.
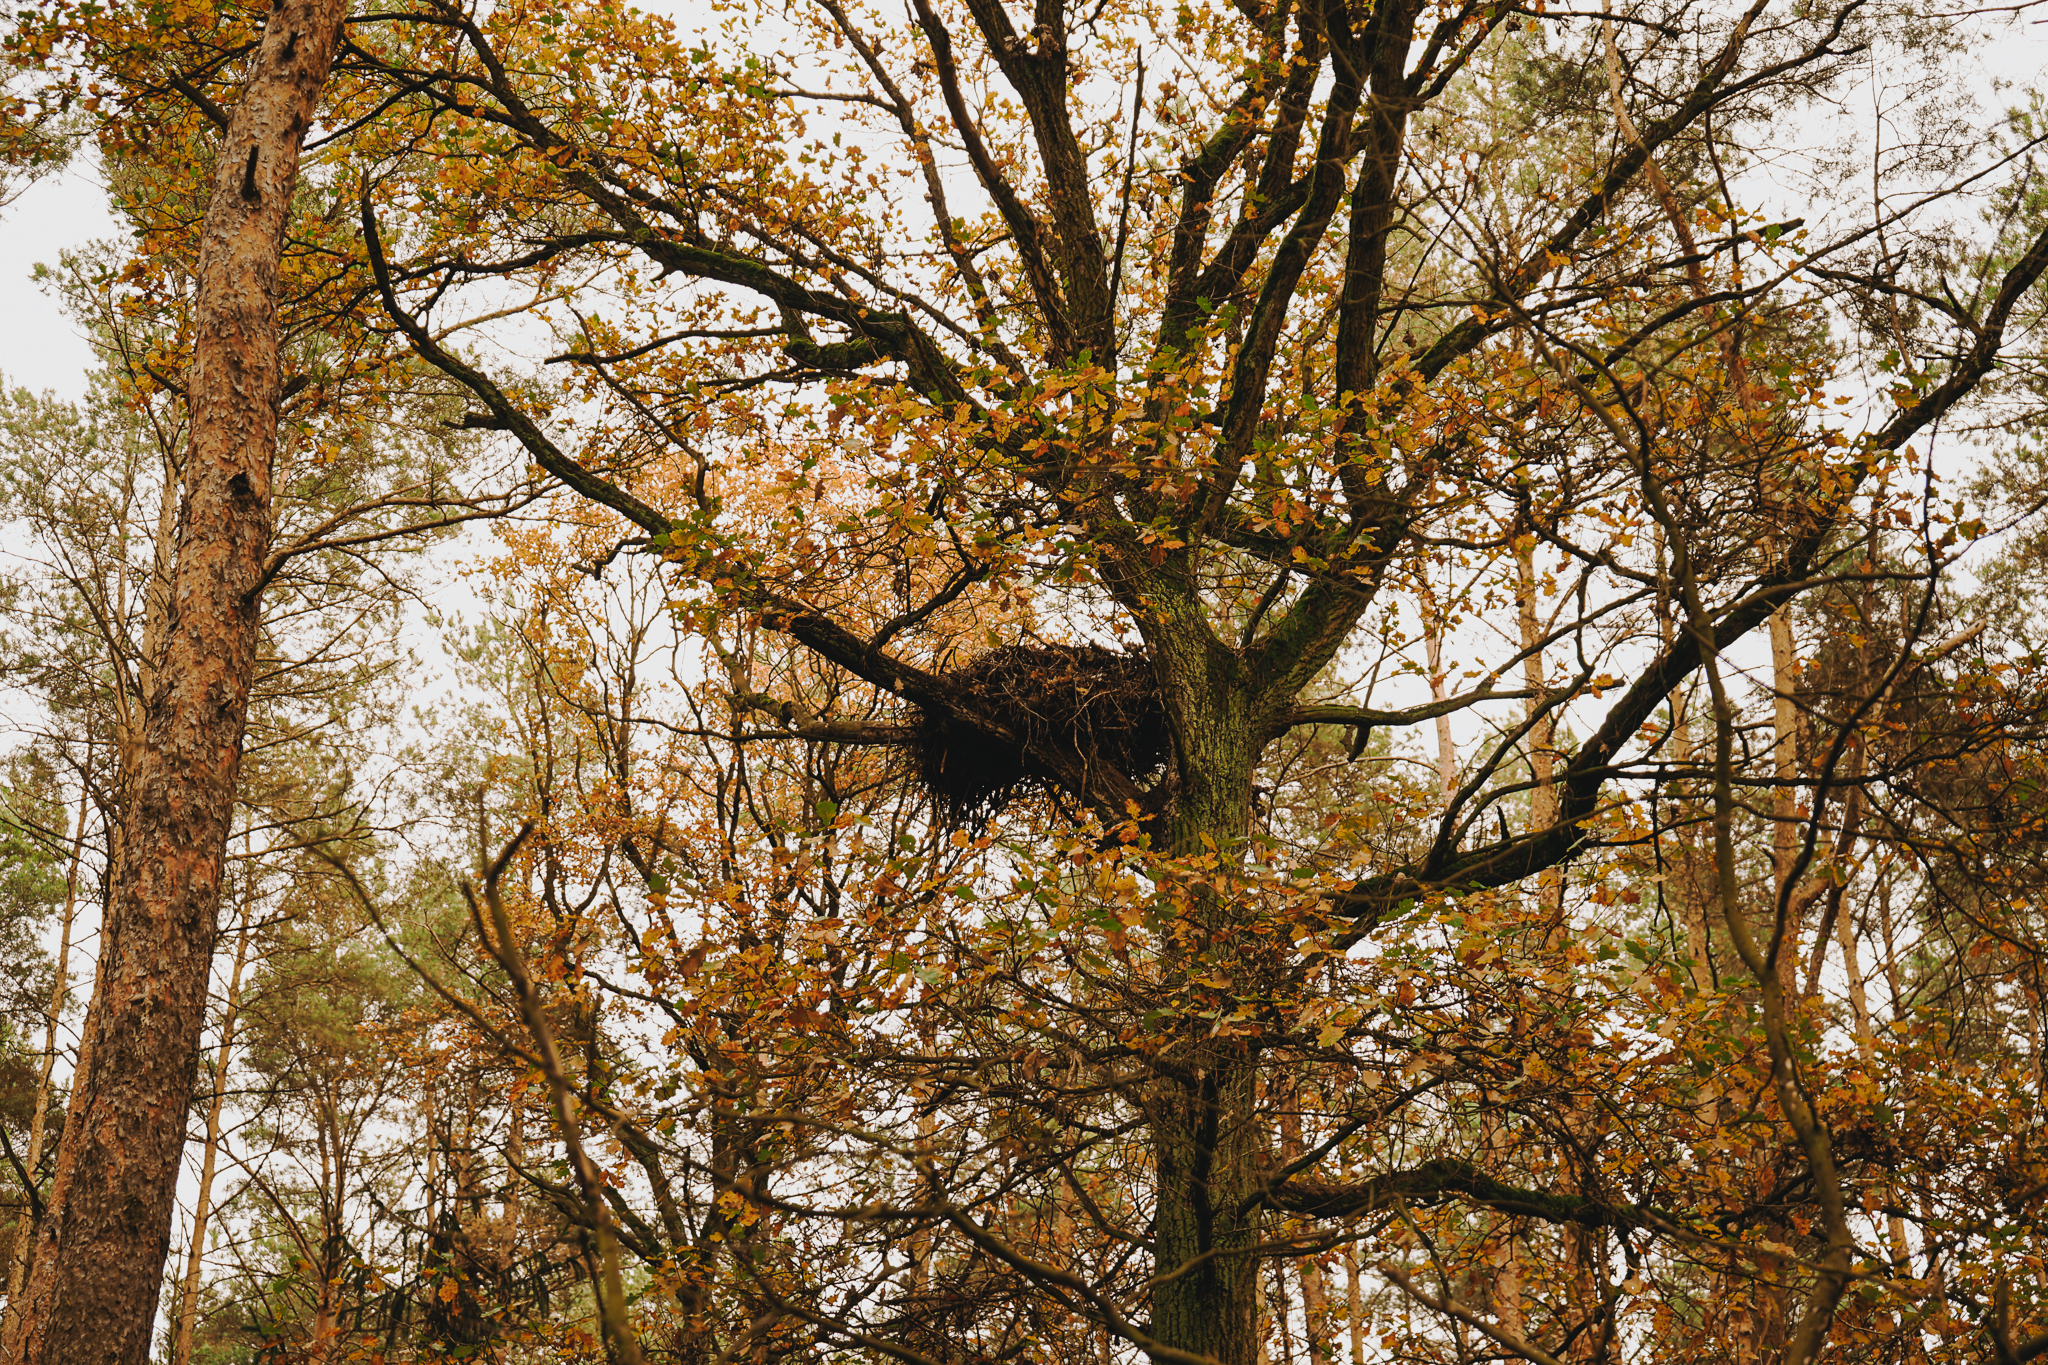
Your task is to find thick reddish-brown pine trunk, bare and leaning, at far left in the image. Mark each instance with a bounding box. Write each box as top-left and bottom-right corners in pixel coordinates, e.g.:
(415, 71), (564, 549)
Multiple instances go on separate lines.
(0, 0), (348, 1365)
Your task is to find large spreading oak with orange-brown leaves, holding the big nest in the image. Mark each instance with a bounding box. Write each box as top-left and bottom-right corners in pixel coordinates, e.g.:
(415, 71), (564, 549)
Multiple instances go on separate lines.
(311, 0), (2048, 1365)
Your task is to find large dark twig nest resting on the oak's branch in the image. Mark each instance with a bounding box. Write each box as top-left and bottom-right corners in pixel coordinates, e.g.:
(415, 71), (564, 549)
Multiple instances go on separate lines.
(913, 645), (1167, 825)
